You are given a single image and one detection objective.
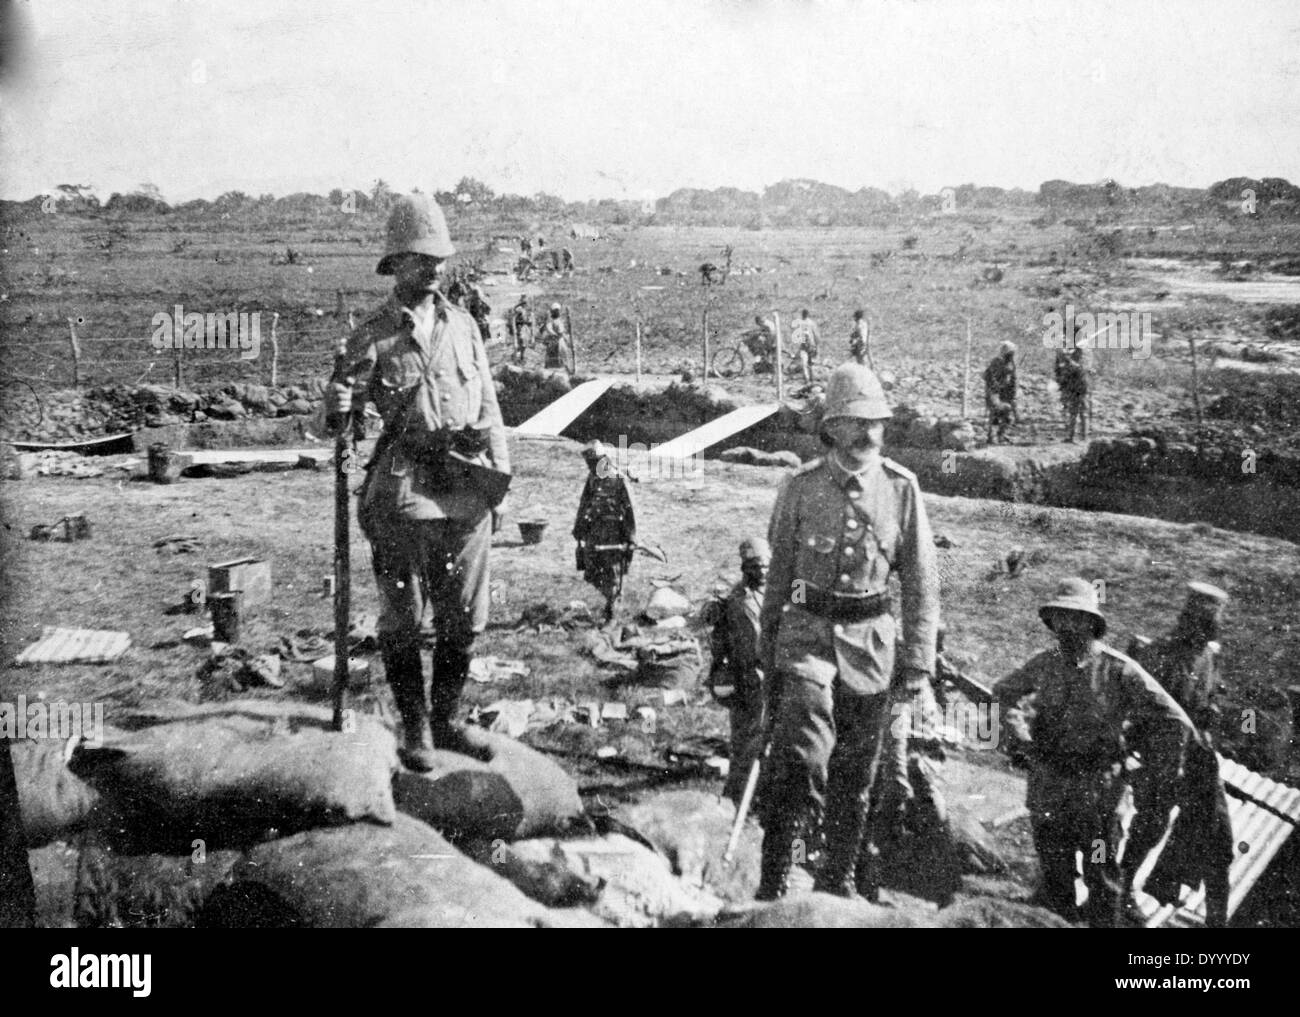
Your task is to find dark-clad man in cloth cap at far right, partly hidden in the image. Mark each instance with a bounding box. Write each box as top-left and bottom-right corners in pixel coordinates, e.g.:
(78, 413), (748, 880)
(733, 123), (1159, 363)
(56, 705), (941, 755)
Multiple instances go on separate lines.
(1125, 583), (1231, 921)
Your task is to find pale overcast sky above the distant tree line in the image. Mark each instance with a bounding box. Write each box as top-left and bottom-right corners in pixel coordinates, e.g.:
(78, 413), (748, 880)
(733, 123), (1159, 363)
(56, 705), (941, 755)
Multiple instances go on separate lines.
(0, 0), (1300, 202)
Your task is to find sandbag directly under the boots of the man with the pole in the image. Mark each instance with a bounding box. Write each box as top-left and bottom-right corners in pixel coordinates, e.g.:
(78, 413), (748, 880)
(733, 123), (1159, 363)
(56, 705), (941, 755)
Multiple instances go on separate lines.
(393, 727), (584, 840)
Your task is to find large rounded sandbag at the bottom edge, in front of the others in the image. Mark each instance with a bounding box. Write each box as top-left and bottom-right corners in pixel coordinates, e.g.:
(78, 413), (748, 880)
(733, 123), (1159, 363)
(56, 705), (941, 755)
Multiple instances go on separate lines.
(199, 815), (569, 929)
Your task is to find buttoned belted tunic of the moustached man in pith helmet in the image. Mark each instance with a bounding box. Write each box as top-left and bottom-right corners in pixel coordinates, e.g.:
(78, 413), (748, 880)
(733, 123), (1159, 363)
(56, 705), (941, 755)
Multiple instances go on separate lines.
(761, 454), (939, 694)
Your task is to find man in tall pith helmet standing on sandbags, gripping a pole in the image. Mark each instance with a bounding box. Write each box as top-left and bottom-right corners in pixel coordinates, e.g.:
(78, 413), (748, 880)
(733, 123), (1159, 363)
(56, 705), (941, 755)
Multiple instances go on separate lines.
(326, 194), (510, 771)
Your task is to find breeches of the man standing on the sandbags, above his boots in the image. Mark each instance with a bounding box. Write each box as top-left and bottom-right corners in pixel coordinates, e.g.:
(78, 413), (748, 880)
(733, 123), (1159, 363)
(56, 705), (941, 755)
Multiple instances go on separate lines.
(371, 512), (491, 652)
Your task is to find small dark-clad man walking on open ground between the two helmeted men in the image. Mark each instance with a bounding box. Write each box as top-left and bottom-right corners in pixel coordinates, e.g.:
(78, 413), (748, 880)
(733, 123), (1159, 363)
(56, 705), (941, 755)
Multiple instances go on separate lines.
(573, 441), (637, 623)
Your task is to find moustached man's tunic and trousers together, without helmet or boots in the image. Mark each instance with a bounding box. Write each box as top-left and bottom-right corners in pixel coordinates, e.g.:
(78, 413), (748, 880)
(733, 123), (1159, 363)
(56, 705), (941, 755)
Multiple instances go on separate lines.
(761, 454), (939, 827)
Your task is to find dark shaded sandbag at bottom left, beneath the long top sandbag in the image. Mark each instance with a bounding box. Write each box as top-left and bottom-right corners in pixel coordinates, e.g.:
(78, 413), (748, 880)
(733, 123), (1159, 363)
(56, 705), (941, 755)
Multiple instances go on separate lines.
(73, 844), (243, 929)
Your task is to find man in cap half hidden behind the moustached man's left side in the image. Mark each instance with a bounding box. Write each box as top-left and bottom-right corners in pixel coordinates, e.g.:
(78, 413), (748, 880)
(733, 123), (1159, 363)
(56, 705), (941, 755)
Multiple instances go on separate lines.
(709, 537), (772, 805)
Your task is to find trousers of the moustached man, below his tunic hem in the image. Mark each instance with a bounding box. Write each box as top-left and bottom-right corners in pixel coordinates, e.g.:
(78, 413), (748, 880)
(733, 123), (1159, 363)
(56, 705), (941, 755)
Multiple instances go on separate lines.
(772, 671), (889, 814)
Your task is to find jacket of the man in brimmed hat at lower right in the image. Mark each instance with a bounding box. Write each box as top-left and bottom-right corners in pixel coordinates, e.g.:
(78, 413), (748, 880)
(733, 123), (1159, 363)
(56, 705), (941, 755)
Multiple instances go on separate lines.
(993, 650), (1193, 782)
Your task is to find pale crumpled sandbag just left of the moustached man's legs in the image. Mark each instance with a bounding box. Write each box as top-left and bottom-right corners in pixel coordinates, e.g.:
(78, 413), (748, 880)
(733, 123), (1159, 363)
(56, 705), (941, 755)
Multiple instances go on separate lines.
(611, 791), (763, 901)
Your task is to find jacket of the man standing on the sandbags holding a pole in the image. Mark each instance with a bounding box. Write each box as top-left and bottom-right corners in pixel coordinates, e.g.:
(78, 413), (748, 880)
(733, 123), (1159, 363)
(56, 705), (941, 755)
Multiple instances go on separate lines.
(348, 291), (510, 525)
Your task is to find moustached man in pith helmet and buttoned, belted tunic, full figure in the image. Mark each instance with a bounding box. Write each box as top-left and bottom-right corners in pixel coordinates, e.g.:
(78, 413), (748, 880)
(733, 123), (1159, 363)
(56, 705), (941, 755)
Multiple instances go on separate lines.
(758, 363), (939, 900)
